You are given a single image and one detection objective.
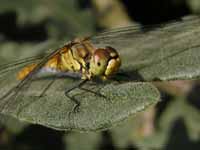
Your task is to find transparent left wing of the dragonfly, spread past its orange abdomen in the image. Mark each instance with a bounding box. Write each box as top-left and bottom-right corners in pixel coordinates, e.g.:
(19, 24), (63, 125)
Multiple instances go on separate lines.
(0, 47), (61, 111)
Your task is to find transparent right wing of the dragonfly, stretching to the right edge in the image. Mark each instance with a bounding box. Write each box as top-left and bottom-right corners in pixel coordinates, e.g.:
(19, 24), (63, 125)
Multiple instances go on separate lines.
(92, 17), (200, 70)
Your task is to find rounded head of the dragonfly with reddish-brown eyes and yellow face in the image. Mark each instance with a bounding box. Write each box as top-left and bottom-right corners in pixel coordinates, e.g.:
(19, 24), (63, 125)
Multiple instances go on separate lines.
(89, 47), (121, 79)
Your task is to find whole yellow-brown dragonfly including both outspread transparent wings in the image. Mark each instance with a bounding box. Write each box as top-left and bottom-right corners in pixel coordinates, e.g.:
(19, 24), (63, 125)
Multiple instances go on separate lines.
(0, 15), (200, 114)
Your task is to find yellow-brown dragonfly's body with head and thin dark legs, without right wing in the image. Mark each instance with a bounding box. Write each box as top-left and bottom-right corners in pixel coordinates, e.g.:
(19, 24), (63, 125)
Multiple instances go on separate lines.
(0, 37), (121, 112)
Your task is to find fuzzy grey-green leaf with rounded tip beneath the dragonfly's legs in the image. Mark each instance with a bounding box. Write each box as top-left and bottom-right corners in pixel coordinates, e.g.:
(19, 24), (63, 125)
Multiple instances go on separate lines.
(0, 79), (160, 131)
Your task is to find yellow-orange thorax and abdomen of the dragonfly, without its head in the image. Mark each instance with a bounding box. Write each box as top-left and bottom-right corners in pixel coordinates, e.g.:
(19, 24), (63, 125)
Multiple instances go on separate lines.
(17, 39), (91, 80)
